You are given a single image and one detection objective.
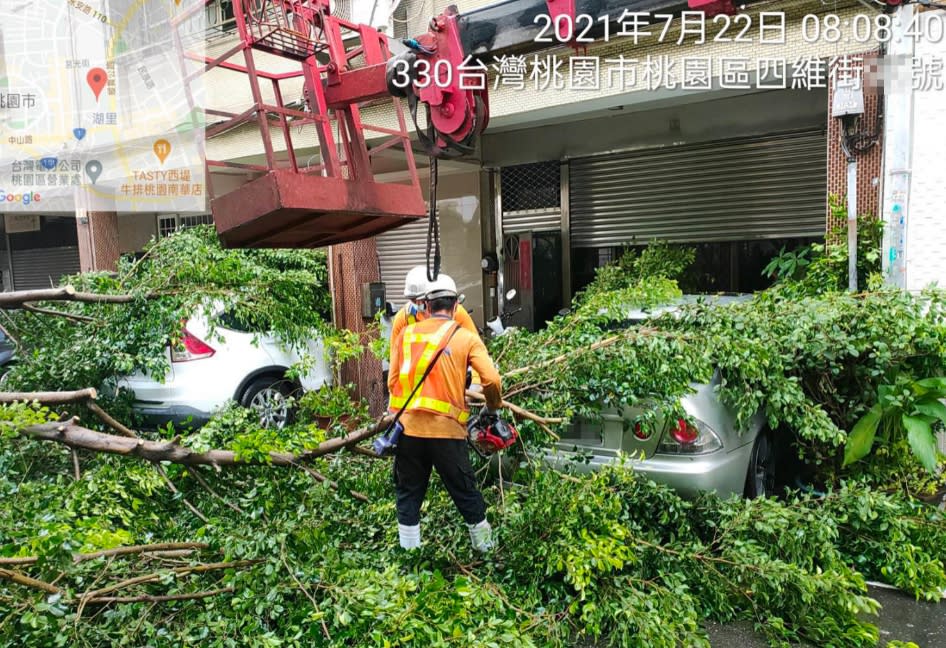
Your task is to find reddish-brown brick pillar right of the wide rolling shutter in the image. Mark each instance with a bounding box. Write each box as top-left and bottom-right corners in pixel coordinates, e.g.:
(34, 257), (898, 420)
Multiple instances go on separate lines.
(827, 53), (883, 232)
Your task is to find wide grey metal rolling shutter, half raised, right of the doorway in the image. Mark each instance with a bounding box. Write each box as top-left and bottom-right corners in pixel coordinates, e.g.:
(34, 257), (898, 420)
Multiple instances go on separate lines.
(569, 130), (827, 247)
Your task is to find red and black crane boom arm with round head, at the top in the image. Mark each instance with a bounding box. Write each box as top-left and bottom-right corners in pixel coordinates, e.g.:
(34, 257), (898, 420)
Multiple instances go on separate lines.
(386, 0), (737, 158)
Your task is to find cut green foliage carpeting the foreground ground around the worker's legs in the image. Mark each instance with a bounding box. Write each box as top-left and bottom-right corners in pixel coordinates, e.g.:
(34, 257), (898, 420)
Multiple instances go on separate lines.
(0, 442), (943, 648)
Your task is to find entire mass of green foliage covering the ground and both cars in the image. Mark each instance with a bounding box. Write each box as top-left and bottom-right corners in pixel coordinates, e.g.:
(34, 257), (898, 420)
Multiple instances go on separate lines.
(0, 233), (946, 648)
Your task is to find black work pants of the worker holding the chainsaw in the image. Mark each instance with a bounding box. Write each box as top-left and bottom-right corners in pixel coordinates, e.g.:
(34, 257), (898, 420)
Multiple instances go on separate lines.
(394, 434), (486, 526)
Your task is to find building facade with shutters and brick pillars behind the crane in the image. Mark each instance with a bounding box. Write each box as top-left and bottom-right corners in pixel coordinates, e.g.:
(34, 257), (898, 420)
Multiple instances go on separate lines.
(0, 0), (933, 398)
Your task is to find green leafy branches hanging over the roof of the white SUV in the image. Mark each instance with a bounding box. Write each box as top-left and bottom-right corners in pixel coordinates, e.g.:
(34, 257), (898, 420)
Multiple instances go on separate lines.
(7, 226), (331, 402)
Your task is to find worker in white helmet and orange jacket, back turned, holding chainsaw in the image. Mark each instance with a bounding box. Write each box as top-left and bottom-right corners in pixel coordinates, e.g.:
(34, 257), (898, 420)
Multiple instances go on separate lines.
(388, 275), (502, 552)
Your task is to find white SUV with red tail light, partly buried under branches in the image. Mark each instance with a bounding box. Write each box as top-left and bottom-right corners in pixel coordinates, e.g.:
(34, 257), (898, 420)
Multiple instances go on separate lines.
(119, 311), (332, 428)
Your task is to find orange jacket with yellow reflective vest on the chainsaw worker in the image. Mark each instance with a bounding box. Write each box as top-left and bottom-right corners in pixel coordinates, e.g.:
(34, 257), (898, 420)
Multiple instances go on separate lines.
(388, 317), (502, 439)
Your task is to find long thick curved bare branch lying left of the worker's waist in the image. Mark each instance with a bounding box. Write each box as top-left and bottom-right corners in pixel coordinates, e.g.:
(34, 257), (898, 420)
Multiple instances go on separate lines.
(19, 416), (391, 467)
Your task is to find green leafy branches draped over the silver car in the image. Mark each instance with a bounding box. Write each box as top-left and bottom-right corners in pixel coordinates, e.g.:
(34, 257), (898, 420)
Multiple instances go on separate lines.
(492, 246), (946, 482)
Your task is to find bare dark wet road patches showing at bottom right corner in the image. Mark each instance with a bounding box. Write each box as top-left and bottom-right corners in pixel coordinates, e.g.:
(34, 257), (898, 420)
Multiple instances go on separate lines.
(708, 587), (946, 648)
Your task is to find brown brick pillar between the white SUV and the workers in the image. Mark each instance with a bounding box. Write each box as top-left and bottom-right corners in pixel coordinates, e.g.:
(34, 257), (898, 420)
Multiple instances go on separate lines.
(330, 238), (387, 414)
